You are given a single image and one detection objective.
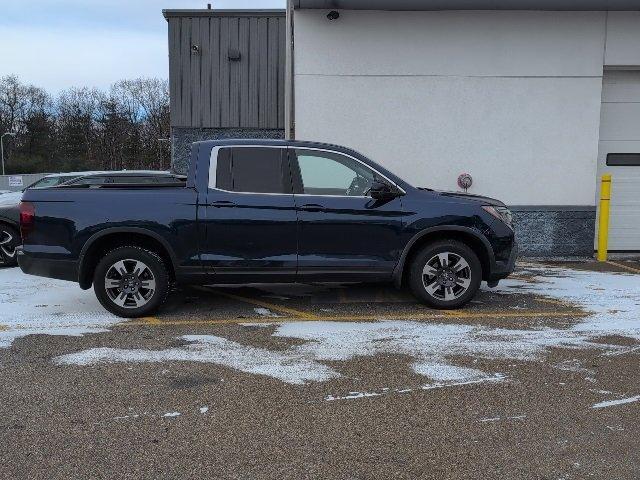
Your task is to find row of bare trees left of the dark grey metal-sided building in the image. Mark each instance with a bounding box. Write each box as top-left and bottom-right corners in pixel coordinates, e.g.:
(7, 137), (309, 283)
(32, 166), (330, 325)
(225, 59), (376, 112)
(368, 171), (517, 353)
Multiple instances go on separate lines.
(0, 76), (171, 173)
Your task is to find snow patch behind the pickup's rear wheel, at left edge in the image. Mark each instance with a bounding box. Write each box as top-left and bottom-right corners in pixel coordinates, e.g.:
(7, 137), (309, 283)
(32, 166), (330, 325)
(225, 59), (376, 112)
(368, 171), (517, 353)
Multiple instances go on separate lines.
(0, 268), (117, 348)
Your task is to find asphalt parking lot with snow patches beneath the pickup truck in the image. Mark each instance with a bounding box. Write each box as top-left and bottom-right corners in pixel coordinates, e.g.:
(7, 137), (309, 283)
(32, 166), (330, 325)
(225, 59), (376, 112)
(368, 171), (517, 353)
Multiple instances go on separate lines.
(0, 261), (640, 479)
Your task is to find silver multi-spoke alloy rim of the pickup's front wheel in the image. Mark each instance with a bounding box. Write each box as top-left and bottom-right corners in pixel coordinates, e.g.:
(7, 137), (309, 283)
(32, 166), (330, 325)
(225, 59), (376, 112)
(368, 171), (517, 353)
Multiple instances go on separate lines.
(422, 252), (471, 301)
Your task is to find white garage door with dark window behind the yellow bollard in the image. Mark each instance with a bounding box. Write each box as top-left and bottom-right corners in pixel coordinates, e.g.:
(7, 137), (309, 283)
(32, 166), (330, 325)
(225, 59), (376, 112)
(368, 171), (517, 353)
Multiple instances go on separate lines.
(598, 71), (640, 251)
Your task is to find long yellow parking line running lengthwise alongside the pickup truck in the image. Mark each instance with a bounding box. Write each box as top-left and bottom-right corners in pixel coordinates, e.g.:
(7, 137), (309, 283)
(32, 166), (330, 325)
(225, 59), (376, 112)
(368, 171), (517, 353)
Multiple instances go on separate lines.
(117, 311), (589, 327)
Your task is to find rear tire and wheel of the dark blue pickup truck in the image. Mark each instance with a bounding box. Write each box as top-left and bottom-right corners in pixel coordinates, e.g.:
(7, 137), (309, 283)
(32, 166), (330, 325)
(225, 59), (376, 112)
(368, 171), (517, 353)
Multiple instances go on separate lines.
(93, 246), (170, 318)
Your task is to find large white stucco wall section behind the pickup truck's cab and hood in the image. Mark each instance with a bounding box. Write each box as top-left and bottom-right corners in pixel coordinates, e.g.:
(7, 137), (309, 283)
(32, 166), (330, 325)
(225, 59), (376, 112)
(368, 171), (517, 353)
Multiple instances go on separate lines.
(294, 10), (608, 205)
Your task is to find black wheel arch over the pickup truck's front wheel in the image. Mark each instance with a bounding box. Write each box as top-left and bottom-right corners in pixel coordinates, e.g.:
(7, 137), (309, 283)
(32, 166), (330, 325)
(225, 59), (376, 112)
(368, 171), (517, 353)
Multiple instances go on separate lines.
(393, 225), (495, 287)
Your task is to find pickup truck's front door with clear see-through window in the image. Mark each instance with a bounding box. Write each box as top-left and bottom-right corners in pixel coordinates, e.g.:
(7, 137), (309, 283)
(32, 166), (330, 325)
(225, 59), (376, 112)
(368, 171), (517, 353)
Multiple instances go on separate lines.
(290, 148), (403, 281)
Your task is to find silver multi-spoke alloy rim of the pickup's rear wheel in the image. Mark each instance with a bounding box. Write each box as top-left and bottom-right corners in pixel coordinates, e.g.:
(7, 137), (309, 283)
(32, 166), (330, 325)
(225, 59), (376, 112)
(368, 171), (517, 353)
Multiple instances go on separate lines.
(104, 258), (156, 308)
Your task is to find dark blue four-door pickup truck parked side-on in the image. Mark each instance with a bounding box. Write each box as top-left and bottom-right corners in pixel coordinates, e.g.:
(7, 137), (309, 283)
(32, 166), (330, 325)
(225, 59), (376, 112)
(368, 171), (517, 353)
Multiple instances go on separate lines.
(18, 140), (517, 317)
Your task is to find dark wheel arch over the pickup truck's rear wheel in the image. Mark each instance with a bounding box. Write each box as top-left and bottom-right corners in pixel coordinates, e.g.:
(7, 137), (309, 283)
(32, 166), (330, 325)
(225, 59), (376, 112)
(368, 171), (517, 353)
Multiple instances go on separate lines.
(78, 227), (176, 290)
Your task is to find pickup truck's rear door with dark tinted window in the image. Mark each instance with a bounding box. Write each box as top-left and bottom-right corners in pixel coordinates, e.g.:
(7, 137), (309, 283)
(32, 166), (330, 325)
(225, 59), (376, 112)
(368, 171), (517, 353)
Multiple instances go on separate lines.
(201, 146), (297, 282)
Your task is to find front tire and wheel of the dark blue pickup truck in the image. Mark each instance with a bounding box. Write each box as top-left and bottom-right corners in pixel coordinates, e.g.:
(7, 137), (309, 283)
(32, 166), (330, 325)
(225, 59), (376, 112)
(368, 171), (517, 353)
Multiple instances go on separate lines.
(409, 240), (482, 310)
